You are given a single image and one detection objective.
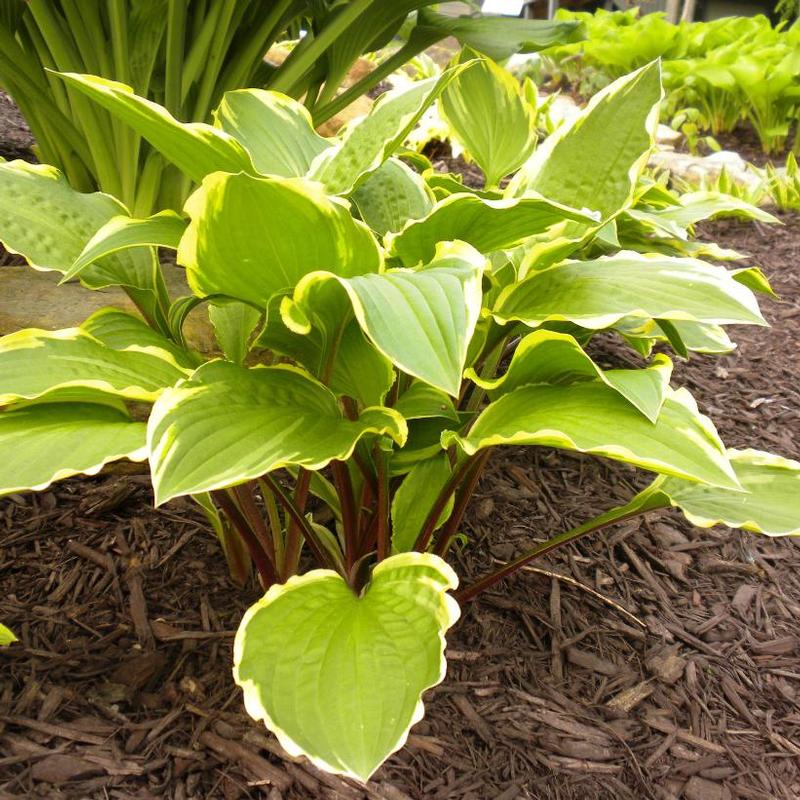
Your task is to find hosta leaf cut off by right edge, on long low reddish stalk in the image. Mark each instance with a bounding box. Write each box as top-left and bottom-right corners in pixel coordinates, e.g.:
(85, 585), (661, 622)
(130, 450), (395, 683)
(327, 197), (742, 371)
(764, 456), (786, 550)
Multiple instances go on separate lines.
(654, 450), (800, 536)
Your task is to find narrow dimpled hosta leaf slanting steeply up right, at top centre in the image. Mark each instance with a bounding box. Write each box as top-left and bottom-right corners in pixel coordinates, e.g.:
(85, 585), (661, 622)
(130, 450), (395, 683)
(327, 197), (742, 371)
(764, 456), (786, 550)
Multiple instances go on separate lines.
(308, 62), (471, 194)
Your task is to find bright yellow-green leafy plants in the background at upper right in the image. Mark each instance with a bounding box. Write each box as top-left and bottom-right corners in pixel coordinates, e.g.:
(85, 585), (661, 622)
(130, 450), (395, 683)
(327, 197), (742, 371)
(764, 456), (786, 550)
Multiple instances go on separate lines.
(550, 9), (800, 154)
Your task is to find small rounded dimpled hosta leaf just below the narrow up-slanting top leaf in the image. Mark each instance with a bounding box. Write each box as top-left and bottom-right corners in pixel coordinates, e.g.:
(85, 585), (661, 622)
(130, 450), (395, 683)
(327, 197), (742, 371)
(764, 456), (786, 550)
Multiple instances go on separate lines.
(350, 158), (433, 236)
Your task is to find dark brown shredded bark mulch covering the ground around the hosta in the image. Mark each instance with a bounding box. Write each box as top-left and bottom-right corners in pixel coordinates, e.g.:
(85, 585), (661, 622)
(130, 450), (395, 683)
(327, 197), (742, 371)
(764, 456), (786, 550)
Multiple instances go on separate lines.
(0, 97), (800, 800)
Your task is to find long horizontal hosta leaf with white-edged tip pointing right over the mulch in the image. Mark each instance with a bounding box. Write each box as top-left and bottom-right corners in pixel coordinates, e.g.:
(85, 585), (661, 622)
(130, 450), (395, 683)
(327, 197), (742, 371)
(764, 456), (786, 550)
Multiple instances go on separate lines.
(492, 251), (766, 329)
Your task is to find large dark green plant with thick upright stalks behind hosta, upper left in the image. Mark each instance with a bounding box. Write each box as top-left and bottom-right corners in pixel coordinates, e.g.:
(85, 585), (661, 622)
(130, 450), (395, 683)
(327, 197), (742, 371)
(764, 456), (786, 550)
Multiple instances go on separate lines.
(0, 0), (581, 215)
